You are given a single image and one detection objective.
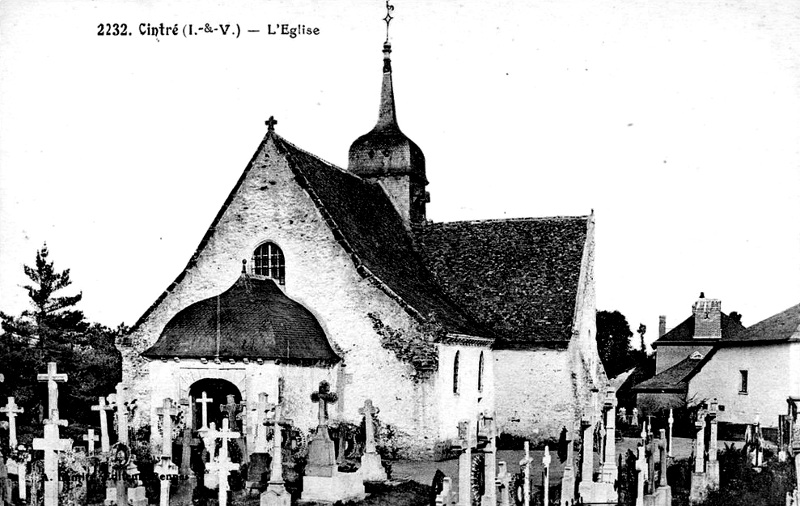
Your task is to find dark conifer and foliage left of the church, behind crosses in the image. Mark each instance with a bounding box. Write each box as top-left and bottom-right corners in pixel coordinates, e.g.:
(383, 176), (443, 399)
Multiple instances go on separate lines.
(0, 244), (126, 443)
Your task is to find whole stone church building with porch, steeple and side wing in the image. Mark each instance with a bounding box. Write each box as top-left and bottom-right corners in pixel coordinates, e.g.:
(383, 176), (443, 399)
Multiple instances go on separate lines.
(122, 39), (606, 457)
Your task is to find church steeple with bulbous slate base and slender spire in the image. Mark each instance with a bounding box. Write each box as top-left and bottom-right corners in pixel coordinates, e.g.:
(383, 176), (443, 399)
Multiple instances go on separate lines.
(348, 2), (429, 227)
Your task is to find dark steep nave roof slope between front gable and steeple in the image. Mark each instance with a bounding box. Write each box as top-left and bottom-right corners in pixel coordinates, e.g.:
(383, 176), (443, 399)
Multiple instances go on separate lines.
(273, 135), (494, 338)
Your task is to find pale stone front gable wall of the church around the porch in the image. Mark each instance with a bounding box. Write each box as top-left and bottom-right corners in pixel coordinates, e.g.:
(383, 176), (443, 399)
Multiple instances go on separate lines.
(123, 136), (438, 452)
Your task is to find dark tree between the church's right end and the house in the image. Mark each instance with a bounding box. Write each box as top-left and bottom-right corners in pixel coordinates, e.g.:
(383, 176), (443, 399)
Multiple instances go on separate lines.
(596, 311), (638, 378)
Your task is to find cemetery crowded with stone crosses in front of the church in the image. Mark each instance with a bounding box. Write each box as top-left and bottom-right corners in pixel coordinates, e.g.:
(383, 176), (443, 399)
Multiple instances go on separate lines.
(0, 362), (800, 506)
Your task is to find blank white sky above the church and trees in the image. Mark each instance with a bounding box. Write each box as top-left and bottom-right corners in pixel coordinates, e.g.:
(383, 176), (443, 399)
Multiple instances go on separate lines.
(0, 0), (800, 348)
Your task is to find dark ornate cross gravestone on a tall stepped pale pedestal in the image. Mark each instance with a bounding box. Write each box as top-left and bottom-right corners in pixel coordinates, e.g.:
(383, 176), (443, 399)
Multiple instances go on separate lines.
(301, 381), (366, 502)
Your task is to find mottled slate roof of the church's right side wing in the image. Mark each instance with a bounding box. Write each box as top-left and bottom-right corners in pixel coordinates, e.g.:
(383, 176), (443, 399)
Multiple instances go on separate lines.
(416, 216), (592, 349)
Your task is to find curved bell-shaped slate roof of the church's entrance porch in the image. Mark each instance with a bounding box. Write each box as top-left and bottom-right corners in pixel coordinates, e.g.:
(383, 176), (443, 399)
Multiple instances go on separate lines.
(142, 274), (339, 363)
